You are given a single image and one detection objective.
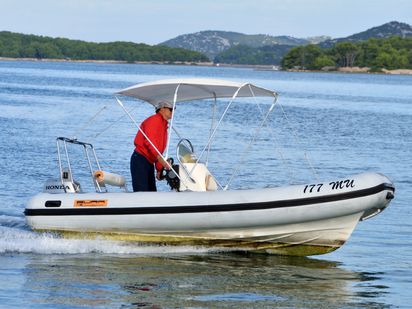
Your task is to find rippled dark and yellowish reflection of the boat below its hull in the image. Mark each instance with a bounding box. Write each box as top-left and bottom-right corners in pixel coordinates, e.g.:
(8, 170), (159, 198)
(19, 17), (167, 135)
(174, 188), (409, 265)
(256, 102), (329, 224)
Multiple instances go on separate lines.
(18, 253), (387, 308)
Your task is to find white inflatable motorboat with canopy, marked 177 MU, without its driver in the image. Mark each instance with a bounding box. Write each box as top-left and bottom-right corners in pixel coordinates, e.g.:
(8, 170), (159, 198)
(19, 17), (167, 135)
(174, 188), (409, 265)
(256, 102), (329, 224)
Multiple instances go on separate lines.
(25, 79), (395, 256)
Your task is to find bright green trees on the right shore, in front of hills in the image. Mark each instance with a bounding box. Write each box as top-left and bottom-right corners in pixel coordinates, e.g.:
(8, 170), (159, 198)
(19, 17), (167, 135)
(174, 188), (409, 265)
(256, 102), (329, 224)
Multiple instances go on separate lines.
(281, 36), (412, 71)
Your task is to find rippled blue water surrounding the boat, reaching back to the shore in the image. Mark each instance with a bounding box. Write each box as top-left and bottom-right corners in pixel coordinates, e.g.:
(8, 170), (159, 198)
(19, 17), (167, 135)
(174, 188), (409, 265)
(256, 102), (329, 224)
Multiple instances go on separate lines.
(0, 61), (412, 308)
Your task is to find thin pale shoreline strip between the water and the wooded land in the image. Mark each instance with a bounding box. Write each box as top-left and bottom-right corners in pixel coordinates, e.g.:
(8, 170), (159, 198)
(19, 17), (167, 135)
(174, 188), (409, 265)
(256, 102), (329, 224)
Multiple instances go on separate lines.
(0, 57), (412, 75)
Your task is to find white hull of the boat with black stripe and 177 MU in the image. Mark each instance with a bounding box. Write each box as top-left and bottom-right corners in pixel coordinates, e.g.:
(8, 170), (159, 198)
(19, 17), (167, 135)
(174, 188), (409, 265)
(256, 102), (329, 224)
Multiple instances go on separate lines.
(25, 173), (394, 256)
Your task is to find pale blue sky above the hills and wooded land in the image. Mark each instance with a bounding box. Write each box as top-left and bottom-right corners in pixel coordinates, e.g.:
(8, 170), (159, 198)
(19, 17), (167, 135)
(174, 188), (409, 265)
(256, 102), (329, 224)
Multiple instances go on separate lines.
(0, 0), (412, 45)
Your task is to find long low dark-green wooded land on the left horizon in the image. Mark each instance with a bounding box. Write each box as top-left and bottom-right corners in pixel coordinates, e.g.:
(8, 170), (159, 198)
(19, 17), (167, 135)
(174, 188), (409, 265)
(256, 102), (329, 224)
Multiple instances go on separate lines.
(0, 31), (209, 63)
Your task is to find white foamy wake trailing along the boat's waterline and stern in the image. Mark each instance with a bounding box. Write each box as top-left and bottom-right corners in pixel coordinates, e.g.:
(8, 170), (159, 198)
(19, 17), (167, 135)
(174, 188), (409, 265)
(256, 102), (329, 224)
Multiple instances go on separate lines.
(0, 226), (222, 256)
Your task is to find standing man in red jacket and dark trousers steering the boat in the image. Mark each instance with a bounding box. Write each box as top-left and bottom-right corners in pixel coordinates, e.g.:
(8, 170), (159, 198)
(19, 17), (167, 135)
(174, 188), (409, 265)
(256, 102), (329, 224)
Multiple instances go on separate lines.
(130, 101), (173, 192)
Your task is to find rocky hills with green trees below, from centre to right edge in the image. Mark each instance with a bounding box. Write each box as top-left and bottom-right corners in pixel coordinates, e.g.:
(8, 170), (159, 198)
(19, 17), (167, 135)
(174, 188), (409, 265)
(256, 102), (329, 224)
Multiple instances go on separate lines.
(161, 21), (412, 73)
